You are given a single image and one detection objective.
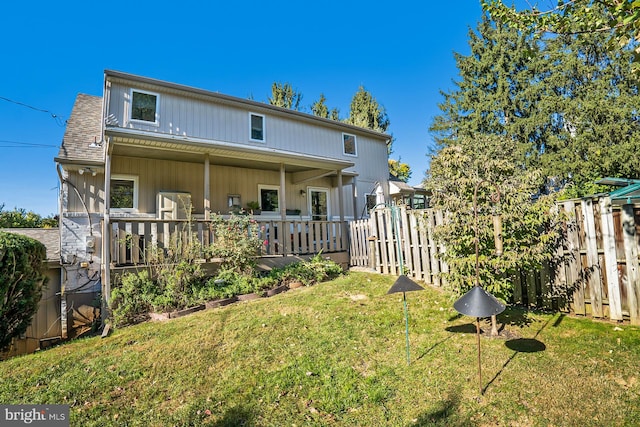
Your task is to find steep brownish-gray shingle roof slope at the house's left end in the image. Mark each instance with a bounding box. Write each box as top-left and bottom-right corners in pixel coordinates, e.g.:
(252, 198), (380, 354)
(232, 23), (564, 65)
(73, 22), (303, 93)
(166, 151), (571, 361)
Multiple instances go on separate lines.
(56, 93), (104, 163)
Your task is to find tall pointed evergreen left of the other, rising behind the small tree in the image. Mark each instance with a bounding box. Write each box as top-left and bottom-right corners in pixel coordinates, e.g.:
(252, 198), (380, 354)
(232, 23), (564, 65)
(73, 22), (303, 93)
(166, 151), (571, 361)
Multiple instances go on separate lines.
(430, 16), (537, 154)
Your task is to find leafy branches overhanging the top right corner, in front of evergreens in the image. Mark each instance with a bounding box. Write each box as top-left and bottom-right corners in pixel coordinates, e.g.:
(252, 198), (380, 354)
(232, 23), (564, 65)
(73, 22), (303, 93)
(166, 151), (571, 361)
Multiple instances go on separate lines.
(481, 0), (640, 69)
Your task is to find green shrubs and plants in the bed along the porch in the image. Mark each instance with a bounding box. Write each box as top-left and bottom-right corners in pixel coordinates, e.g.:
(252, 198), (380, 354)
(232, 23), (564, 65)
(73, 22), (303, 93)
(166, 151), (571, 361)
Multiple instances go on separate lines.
(111, 211), (342, 326)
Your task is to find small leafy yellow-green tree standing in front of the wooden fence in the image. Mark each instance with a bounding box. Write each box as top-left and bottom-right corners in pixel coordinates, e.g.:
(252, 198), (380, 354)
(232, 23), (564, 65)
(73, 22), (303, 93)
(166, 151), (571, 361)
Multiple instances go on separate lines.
(425, 134), (558, 334)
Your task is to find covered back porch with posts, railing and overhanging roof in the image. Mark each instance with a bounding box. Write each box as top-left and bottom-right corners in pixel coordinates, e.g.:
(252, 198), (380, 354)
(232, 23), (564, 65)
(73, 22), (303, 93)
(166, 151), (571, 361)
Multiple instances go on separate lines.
(101, 127), (358, 274)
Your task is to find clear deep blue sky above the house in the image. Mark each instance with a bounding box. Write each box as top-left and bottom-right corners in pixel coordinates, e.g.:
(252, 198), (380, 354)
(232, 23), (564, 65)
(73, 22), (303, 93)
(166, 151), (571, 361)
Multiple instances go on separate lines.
(0, 0), (481, 216)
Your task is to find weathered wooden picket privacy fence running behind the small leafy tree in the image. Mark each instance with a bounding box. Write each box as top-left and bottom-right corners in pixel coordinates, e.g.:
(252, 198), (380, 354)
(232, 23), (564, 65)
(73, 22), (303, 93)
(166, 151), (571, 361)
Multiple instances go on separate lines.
(349, 201), (640, 324)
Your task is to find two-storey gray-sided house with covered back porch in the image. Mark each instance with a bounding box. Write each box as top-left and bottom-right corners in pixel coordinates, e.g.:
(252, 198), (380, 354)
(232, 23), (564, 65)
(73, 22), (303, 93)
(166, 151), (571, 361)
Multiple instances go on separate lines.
(55, 71), (390, 326)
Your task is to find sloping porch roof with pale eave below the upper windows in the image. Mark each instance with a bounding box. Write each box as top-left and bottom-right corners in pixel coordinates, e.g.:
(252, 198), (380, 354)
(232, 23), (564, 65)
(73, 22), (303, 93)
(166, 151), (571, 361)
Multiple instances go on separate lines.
(105, 126), (354, 172)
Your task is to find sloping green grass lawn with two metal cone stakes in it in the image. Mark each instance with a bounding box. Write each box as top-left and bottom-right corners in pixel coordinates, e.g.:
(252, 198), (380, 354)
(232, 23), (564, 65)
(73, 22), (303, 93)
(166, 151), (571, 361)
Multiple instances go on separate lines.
(0, 272), (640, 427)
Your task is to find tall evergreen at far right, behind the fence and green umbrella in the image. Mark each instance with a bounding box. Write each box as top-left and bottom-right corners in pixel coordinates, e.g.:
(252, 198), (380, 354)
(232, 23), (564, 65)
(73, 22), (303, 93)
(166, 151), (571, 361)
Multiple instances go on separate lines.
(532, 30), (640, 197)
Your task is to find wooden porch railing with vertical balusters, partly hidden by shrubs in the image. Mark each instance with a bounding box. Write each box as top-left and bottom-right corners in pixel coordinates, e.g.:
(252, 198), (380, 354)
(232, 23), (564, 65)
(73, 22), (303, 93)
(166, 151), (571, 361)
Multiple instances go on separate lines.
(109, 218), (348, 266)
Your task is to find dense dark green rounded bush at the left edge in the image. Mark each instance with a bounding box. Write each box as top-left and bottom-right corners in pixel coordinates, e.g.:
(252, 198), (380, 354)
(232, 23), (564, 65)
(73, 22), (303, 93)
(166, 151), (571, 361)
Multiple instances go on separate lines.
(0, 232), (47, 349)
